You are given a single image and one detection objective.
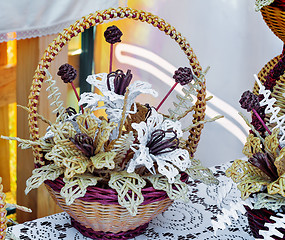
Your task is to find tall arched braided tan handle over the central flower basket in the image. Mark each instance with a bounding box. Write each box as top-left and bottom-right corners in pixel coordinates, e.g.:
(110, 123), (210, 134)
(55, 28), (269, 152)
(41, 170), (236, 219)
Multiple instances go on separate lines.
(28, 7), (206, 162)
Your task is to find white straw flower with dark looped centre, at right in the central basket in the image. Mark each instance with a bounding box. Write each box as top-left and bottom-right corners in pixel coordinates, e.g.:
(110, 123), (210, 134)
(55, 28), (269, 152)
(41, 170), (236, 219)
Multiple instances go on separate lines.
(127, 109), (191, 183)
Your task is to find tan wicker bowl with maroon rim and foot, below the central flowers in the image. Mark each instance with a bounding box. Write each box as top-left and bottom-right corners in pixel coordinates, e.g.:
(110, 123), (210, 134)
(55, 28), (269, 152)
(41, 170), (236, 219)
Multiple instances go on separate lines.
(46, 179), (173, 239)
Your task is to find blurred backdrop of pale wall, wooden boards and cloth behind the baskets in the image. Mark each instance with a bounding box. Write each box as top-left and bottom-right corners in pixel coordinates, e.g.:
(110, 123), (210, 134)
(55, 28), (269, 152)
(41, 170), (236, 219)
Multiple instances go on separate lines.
(0, 0), (283, 222)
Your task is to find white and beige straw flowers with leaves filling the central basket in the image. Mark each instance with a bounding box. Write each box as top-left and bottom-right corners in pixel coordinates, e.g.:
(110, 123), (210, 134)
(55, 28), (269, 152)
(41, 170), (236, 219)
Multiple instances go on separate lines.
(9, 46), (220, 216)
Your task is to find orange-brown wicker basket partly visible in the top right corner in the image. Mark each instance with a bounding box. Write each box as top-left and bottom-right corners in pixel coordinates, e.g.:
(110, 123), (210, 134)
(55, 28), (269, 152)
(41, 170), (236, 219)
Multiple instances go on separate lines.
(260, 5), (285, 42)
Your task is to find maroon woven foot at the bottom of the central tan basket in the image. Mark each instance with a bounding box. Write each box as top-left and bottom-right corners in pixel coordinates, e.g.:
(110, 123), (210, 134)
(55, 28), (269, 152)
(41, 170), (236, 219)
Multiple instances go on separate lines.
(70, 217), (148, 240)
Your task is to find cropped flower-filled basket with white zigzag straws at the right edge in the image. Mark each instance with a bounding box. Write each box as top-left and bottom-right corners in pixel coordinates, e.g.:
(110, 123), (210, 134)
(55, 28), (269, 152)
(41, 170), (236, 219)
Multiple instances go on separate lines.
(226, 49), (285, 239)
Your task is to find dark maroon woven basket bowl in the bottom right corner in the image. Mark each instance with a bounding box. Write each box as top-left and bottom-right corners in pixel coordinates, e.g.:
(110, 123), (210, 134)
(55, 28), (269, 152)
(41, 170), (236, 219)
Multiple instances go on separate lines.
(244, 206), (285, 240)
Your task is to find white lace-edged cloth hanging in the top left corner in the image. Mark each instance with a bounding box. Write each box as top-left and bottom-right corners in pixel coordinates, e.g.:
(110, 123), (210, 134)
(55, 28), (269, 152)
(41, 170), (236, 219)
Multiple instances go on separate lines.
(0, 0), (118, 42)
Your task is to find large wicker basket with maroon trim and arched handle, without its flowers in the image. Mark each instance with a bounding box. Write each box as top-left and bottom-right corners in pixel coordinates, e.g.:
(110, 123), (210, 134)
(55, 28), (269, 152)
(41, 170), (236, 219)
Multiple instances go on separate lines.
(28, 8), (206, 239)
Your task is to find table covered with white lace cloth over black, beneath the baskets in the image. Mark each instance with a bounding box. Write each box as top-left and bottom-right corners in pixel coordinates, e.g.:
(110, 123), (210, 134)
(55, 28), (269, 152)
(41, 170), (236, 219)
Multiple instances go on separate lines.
(8, 163), (251, 240)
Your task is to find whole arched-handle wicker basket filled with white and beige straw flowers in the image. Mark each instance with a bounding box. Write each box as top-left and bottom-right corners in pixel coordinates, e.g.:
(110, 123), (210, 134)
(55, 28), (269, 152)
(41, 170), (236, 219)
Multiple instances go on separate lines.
(1, 8), (222, 239)
